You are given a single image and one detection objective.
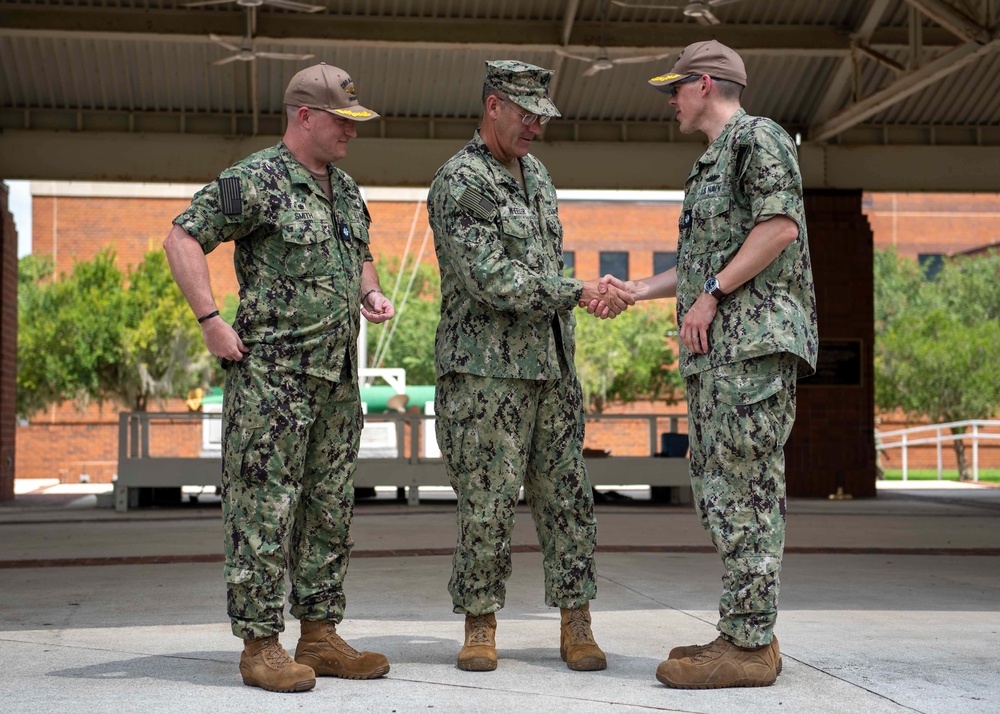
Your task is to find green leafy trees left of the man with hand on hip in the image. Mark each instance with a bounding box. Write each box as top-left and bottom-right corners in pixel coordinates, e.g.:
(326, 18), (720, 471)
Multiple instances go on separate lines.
(17, 249), (208, 415)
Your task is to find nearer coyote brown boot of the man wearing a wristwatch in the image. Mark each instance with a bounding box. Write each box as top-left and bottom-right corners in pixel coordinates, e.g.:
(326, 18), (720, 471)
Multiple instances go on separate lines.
(656, 637), (781, 689)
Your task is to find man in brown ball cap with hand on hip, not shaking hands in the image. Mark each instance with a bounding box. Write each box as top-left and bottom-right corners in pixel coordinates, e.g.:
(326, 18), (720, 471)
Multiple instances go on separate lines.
(164, 64), (393, 692)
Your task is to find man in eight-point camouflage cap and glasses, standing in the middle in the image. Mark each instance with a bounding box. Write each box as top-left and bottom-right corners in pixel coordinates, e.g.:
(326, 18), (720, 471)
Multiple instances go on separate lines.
(427, 60), (626, 671)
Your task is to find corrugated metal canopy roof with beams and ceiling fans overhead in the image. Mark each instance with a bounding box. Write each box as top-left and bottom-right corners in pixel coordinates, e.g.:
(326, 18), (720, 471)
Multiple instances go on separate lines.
(0, 0), (1000, 190)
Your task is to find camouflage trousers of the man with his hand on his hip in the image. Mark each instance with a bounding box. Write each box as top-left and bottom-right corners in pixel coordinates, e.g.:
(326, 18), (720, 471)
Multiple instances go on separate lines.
(222, 355), (361, 639)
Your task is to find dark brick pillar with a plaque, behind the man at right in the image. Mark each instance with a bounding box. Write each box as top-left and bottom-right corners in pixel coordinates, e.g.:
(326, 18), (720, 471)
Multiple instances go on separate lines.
(785, 190), (875, 498)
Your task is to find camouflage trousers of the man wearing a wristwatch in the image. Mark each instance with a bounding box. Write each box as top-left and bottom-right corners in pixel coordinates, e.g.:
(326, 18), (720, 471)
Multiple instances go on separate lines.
(687, 353), (798, 647)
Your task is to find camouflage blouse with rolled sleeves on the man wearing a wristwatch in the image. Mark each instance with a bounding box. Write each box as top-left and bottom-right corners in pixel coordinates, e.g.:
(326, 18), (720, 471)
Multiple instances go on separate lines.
(677, 109), (818, 377)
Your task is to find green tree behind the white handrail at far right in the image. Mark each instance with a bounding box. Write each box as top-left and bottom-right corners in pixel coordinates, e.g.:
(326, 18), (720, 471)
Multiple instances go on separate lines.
(875, 253), (1000, 479)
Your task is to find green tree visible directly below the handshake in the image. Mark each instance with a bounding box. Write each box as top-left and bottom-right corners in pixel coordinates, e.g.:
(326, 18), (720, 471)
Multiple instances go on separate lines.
(576, 302), (684, 412)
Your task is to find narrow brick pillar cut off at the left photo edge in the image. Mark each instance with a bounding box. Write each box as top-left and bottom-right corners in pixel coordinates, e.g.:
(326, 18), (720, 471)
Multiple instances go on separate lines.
(0, 182), (17, 501)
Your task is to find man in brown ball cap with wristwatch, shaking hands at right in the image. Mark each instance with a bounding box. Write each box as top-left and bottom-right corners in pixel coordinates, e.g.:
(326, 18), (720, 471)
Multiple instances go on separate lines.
(597, 40), (817, 689)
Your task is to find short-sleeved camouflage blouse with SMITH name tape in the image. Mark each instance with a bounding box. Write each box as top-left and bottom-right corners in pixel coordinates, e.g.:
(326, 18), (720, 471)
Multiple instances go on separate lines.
(174, 143), (372, 381)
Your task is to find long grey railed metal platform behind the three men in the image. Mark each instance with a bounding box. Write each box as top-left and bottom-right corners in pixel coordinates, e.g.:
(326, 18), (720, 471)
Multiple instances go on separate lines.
(114, 412), (691, 512)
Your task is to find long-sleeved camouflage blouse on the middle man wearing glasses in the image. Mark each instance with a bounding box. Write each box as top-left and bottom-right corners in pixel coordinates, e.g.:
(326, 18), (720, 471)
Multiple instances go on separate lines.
(427, 132), (583, 379)
